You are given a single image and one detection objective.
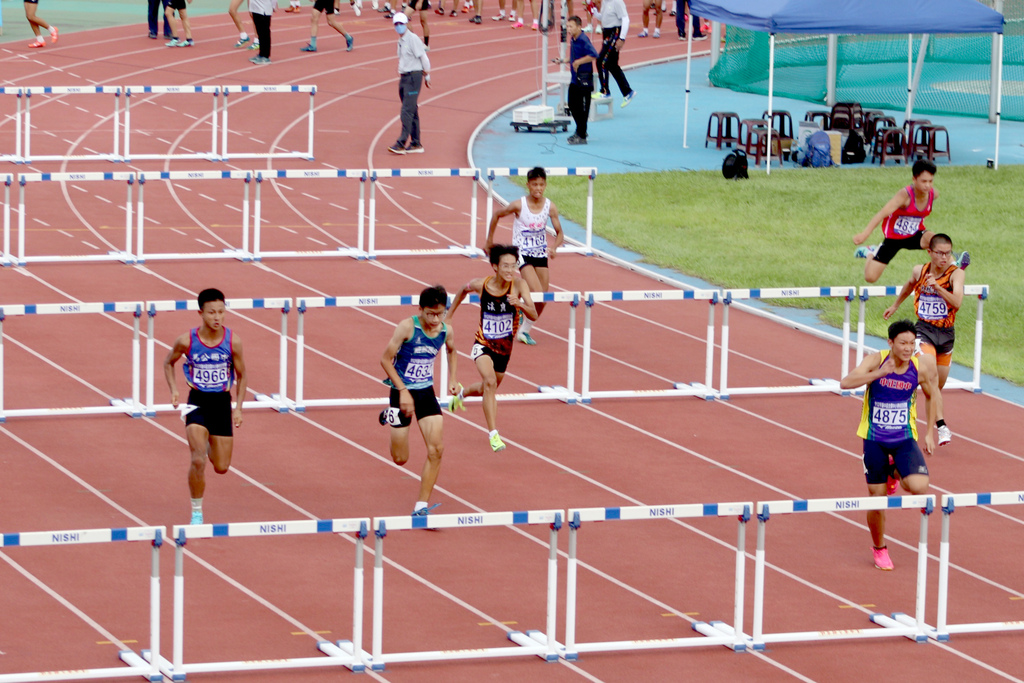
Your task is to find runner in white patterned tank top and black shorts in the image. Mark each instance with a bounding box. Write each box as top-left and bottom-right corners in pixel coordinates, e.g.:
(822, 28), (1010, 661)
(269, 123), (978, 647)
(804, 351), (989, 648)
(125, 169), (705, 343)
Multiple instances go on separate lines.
(483, 166), (564, 345)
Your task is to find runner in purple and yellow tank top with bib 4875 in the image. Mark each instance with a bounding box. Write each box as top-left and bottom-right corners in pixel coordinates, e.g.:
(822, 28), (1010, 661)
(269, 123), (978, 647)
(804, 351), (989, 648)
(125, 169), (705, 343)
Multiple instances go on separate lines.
(840, 321), (942, 571)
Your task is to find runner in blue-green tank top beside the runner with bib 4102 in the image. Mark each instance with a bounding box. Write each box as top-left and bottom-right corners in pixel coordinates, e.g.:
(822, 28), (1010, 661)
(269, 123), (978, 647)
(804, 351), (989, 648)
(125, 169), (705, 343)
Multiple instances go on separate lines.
(380, 285), (459, 515)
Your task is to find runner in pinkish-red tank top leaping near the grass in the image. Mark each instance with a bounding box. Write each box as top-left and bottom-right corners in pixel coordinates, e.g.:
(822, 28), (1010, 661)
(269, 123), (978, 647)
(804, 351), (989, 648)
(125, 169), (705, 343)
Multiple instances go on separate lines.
(853, 159), (971, 283)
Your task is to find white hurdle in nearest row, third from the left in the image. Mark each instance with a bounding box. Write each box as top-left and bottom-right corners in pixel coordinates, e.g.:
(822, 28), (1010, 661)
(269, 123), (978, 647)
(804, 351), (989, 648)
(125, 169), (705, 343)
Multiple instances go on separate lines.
(368, 510), (562, 671)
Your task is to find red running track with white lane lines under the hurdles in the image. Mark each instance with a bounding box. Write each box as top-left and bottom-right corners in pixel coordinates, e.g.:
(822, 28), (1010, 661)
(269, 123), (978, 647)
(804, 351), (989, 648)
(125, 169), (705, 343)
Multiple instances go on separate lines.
(0, 10), (1024, 682)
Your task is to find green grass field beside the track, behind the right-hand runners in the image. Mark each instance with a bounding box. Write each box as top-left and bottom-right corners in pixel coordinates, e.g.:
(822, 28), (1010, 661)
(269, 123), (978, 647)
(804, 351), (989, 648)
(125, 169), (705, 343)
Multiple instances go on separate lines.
(532, 166), (1024, 385)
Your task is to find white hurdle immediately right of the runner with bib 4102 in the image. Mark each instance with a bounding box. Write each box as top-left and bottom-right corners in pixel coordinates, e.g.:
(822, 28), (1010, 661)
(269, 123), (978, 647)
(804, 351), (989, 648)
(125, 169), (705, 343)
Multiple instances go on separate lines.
(580, 290), (719, 403)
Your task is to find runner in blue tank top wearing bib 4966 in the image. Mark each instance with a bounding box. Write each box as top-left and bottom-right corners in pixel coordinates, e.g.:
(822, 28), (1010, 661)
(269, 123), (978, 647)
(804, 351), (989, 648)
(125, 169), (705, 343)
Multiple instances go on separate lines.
(164, 289), (248, 524)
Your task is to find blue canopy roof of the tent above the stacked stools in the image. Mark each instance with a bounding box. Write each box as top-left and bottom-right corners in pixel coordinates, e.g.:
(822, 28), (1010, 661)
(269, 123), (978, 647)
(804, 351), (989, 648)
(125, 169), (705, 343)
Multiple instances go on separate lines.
(690, 0), (1002, 35)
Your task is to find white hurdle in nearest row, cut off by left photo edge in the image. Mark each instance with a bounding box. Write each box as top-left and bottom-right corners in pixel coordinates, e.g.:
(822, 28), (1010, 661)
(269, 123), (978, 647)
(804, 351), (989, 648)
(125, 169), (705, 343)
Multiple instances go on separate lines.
(0, 526), (167, 683)
